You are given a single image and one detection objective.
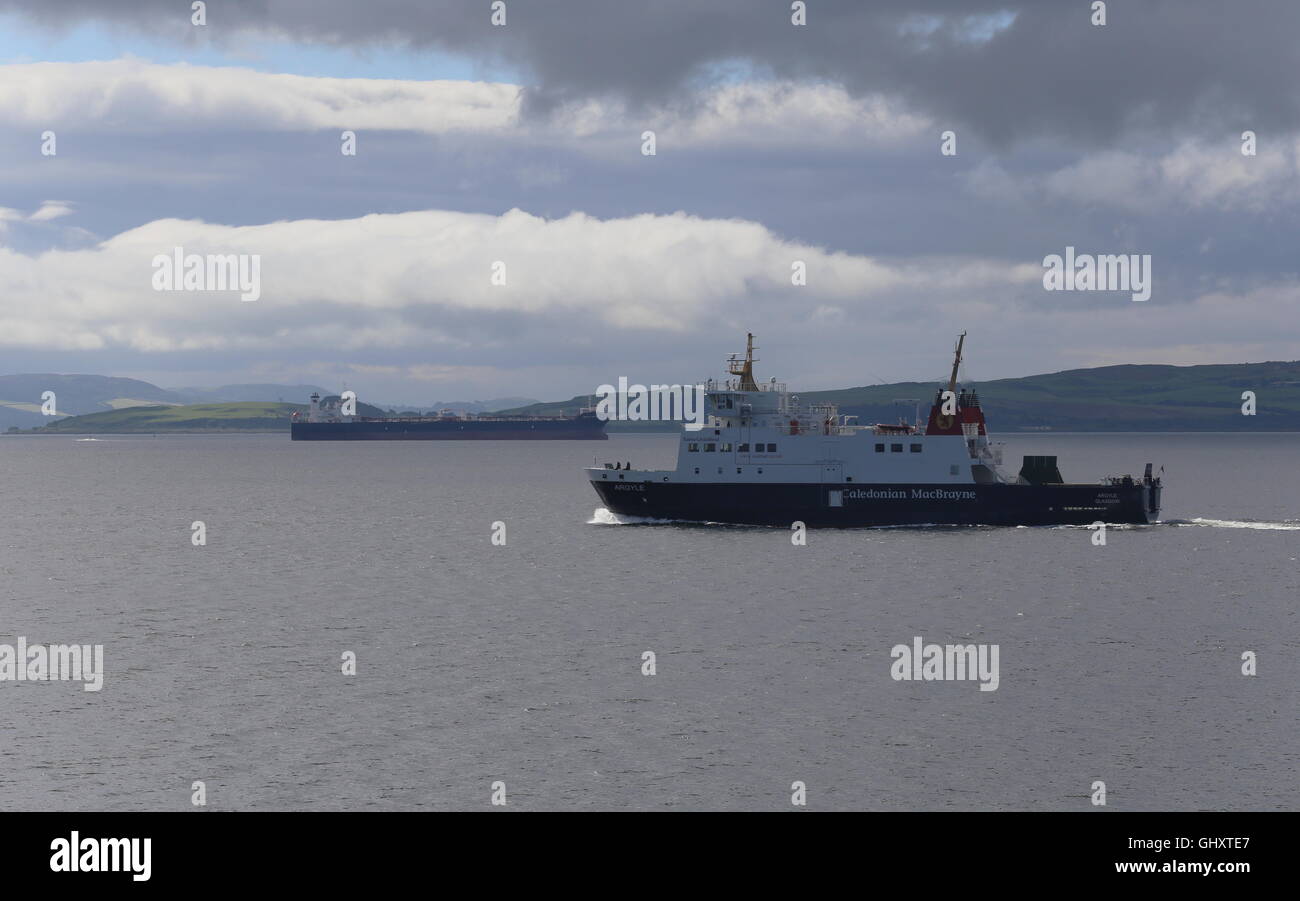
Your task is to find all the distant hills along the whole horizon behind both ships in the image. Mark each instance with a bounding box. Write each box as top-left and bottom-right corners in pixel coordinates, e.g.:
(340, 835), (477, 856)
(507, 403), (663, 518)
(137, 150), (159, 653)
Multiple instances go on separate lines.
(12, 361), (1300, 433)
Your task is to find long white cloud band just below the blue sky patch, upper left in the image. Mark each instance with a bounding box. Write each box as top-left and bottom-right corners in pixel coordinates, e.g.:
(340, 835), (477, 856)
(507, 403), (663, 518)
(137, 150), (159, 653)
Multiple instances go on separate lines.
(0, 59), (928, 146)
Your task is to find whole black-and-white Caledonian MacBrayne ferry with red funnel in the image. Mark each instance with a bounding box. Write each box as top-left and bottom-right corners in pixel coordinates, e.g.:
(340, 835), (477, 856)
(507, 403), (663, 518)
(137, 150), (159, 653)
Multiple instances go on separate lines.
(586, 332), (1161, 527)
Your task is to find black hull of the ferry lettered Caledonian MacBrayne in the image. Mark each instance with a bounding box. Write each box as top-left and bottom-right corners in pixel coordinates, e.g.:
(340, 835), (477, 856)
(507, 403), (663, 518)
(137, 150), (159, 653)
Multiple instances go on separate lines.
(592, 471), (1161, 528)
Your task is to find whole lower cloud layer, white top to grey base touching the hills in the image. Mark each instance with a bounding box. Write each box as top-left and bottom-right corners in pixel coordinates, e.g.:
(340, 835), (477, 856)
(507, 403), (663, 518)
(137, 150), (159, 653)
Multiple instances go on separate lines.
(0, 209), (1300, 398)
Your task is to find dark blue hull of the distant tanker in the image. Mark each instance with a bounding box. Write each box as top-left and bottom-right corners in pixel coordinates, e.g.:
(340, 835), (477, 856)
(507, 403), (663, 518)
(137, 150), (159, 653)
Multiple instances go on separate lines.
(289, 416), (608, 441)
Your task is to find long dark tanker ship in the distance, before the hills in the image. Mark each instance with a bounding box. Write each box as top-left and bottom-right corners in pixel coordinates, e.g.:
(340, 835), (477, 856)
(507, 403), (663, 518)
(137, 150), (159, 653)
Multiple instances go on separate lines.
(289, 394), (608, 441)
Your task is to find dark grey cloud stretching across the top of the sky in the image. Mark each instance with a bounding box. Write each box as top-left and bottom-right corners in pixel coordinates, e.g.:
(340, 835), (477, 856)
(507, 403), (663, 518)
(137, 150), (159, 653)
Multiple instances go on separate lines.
(10, 0), (1300, 144)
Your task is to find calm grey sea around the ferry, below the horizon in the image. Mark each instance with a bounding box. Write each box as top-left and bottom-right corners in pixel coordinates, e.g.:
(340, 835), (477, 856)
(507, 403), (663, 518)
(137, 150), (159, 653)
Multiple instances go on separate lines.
(0, 434), (1300, 810)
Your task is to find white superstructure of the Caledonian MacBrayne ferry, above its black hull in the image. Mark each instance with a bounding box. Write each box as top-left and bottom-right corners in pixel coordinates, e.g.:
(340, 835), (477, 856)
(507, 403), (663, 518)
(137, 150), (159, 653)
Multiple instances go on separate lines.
(589, 335), (1015, 485)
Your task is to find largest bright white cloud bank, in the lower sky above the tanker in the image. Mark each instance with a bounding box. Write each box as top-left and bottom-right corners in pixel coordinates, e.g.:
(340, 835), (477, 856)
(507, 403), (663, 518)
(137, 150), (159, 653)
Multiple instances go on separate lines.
(0, 209), (1041, 351)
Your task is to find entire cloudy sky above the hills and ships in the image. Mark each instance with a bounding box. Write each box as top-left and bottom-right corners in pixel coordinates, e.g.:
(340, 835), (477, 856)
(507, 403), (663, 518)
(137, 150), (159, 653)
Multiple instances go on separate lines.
(0, 0), (1300, 404)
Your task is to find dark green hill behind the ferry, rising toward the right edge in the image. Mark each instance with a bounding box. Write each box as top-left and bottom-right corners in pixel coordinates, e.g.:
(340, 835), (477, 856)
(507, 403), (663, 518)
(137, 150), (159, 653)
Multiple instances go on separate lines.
(503, 361), (1300, 432)
